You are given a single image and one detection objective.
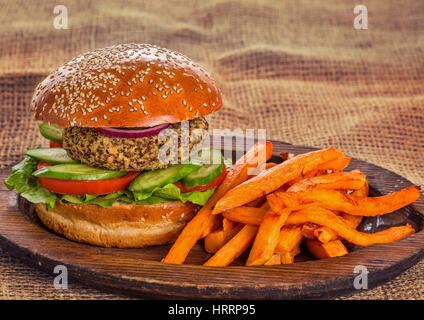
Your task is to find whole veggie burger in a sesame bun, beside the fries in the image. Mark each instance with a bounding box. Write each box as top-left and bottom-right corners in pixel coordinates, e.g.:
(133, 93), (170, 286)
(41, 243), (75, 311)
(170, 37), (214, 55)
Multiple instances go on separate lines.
(5, 44), (228, 247)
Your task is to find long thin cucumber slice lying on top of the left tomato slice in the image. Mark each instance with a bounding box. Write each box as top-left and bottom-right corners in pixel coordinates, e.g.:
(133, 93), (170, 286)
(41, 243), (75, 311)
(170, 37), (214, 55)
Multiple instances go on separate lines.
(33, 164), (127, 180)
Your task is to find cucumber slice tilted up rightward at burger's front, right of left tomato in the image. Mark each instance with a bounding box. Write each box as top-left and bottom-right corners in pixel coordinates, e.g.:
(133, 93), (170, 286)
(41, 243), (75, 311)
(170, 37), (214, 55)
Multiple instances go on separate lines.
(128, 164), (200, 192)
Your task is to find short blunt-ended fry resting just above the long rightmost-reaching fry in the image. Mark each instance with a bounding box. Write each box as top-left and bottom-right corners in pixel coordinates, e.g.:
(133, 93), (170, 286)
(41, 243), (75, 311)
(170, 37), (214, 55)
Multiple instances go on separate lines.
(287, 171), (366, 192)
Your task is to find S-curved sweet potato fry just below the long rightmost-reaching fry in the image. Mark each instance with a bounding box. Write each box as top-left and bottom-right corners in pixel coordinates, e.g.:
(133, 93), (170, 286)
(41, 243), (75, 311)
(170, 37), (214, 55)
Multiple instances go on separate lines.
(286, 207), (415, 247)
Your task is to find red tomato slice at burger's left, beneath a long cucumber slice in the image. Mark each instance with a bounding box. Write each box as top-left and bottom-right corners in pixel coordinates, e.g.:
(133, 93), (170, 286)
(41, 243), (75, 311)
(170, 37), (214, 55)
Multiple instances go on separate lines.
(37, 162), (141, 196)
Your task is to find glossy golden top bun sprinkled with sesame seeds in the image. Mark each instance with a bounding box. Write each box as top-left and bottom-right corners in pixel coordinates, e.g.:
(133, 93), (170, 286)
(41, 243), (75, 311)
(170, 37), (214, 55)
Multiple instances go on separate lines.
(31, 44), (222, 127)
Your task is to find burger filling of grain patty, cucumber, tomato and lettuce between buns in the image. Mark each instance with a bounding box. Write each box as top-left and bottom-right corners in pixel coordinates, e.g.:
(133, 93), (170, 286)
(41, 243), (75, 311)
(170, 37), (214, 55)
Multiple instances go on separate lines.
(5, 118), (231, 209)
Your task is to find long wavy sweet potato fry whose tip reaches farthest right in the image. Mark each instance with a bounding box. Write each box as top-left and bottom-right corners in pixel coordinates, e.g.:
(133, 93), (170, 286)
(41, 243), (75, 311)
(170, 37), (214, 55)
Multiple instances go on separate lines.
(275, 186), (420, 217)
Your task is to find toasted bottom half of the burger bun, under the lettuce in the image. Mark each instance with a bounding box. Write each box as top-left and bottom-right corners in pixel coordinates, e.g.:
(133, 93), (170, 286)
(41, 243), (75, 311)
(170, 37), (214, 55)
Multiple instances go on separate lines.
(35, 202), (197, 248)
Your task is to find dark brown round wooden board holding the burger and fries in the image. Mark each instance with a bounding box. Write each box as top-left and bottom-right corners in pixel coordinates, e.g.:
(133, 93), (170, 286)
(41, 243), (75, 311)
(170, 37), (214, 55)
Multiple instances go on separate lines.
(0, 141), (424, 299)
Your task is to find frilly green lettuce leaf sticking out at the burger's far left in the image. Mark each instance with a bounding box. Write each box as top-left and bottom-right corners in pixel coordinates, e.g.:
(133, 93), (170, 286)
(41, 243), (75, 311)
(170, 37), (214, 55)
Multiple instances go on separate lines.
(4, 157), (57, 210)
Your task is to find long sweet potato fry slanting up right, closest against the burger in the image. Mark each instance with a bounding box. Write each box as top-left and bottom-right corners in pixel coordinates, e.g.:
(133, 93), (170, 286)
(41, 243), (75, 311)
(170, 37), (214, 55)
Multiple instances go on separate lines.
(163, 141), (272, 264)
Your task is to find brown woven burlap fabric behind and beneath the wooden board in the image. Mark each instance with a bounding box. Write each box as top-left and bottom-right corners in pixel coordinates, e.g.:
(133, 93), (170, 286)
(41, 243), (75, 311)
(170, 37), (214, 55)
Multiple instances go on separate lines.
(0, 0), (424, 299)
